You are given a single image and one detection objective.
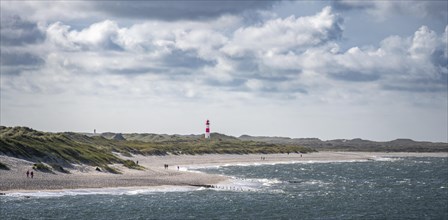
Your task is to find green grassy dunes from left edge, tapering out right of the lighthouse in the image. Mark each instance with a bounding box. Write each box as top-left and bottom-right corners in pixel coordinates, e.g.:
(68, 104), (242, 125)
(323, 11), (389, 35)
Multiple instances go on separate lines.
(0, 126), (313, 170)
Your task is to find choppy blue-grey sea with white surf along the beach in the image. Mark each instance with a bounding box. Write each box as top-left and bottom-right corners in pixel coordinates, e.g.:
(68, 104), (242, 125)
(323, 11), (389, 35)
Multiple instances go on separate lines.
(0, 157), (448, 220)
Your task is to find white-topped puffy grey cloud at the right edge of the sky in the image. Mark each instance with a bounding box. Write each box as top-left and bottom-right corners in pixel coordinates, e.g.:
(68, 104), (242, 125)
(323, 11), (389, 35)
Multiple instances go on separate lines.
(303, 26), (448, 92)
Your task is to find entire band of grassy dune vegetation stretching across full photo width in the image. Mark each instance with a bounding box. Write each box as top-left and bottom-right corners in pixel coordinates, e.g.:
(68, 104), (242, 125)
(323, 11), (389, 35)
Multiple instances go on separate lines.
(0, 126), (448, 173)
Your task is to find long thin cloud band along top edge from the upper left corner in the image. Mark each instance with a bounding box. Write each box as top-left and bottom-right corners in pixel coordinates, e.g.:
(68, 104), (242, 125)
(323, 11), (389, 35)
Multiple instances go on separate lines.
(2, 0), (280, 23)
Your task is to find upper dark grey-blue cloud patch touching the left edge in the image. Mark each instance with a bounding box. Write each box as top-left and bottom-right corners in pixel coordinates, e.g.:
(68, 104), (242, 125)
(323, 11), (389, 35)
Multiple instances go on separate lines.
(0, 15), (45, 46)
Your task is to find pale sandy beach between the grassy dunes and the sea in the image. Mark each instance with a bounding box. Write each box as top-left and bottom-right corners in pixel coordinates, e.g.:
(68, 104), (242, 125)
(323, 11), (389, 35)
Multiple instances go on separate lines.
(0, 152), (448, 193)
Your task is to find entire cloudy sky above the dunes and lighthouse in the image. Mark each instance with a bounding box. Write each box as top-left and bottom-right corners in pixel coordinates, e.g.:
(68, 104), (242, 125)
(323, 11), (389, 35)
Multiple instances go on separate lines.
(0, 0), (448, 142)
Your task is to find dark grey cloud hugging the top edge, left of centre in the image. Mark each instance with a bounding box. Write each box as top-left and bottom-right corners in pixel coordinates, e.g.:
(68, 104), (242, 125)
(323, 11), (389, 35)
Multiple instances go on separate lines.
(93, 0), (277, 21)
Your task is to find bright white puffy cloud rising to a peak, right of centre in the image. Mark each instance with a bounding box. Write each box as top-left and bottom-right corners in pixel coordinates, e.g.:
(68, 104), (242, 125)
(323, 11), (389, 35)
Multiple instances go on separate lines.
(223, 7), (343, 57)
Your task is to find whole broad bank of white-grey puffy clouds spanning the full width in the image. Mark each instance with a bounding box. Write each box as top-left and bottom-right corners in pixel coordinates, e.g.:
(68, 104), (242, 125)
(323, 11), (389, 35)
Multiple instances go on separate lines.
(2, 4), (448, 107)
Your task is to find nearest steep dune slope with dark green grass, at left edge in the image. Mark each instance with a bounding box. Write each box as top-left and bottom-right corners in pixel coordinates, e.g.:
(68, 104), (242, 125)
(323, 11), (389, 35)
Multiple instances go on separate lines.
(0, 127), (121, 166)
